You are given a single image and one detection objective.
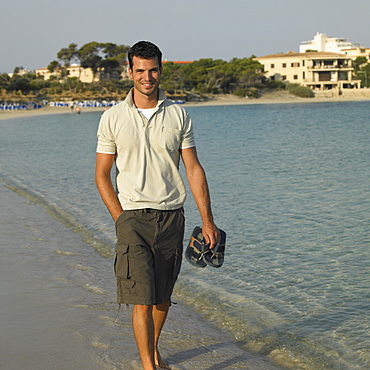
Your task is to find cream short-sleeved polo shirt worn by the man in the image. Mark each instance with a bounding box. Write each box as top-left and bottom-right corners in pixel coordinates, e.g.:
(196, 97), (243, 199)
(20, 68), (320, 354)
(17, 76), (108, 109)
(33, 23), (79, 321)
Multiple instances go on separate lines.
(97, 90), (195, 210)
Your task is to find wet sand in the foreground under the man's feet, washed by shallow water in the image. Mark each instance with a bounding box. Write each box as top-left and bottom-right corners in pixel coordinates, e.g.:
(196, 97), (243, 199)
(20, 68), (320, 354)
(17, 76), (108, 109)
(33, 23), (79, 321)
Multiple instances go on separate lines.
(0, 180), (284, 370)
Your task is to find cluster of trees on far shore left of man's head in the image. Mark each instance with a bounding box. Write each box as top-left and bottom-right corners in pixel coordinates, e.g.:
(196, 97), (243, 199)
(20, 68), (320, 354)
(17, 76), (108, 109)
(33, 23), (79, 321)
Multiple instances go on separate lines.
(0, 41), (129, 98)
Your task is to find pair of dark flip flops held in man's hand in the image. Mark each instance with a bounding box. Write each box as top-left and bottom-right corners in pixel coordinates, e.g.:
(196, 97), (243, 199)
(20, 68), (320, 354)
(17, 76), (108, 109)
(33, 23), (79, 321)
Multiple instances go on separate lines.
(185, 226), (226, 268)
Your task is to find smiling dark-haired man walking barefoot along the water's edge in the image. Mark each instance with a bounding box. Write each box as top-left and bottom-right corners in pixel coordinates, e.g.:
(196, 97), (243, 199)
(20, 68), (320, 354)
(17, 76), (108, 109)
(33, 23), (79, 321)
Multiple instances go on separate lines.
(95, 41), (219, 370)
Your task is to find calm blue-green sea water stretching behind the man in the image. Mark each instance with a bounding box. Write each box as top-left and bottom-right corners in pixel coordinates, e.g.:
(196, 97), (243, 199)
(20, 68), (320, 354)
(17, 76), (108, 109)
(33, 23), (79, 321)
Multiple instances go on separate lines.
(0, 101), (370, 370)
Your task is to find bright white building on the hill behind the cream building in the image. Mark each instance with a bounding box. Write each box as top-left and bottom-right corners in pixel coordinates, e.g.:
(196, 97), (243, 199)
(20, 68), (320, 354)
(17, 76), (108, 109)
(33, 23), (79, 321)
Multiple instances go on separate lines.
(299, 32), (360, 54)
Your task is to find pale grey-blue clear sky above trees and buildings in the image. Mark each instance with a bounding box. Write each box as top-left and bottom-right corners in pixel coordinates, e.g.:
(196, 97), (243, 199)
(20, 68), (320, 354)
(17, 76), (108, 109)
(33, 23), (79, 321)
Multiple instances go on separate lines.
(0, 0), (370, 73)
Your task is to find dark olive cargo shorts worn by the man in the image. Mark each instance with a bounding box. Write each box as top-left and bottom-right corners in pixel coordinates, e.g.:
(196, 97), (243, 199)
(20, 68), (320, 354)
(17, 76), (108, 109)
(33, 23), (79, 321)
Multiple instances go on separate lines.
(114, 208), (185, 305)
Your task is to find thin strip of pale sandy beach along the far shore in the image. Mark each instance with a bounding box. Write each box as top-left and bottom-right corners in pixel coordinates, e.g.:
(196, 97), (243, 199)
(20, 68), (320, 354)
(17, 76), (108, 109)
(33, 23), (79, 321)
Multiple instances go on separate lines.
(0, 91), (370, 121)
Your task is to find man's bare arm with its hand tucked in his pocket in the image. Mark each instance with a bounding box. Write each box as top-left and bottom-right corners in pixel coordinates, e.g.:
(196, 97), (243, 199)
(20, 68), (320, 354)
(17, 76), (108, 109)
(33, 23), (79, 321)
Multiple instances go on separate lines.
(95, 153), (123, 221)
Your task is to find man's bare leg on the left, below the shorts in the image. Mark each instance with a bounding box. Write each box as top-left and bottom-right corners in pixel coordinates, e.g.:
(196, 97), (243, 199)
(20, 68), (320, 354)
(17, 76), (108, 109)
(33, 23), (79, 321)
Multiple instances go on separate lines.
(132, 305), (156, 370)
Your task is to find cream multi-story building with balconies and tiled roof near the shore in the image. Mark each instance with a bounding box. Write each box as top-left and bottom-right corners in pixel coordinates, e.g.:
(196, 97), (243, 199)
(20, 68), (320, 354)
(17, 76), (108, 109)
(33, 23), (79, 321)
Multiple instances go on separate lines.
(255, 52), (361, 90)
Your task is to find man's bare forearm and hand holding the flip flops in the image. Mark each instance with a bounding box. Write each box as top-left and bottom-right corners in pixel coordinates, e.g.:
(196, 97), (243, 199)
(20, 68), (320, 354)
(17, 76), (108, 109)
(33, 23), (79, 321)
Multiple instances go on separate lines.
(180, 147), (220, 248)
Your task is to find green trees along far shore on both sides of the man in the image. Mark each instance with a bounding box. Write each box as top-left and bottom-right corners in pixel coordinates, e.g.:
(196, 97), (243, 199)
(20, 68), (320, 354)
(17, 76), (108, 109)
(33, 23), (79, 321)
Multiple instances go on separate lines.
(0, 42), (370, 99)
